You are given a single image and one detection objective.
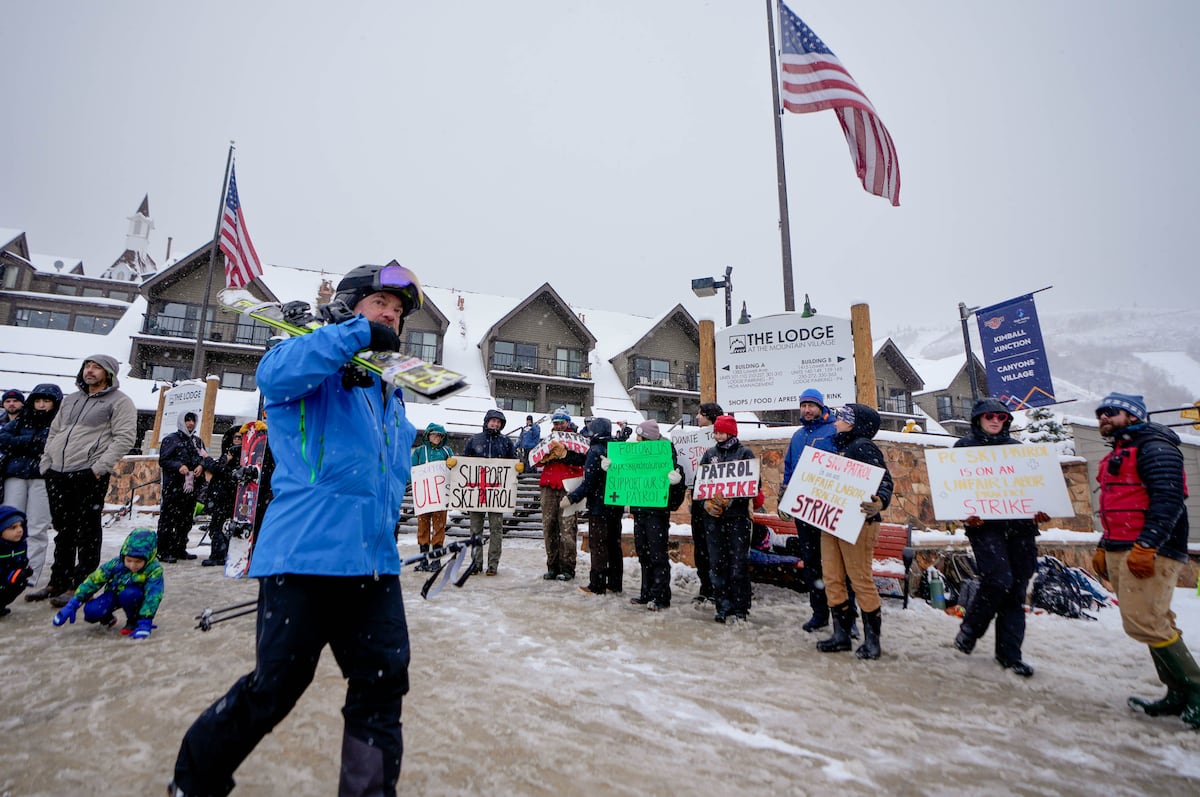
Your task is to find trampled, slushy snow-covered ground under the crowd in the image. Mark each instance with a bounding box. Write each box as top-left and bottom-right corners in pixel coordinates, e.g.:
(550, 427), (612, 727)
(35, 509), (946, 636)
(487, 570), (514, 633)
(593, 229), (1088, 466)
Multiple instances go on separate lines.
(0, 523), (1200, 797)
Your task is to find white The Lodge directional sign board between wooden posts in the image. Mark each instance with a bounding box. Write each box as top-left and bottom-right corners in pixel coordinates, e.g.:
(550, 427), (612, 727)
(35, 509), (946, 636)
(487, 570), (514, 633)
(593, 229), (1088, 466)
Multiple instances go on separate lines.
(716, 313), (854, 413)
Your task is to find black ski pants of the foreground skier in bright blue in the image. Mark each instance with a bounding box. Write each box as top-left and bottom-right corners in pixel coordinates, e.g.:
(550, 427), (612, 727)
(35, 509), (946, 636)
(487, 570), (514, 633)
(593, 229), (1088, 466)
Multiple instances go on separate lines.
(175, 575), (409, 797)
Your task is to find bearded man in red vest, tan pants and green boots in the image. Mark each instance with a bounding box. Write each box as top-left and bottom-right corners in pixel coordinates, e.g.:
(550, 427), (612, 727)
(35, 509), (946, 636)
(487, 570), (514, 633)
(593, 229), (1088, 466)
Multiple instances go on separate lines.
(1092, 392), (1200, 729)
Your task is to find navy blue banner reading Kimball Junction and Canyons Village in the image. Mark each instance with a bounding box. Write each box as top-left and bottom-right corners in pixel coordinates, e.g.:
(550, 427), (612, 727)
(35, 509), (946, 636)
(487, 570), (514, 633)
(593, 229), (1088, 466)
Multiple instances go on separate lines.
(976, 294), (1056, 411)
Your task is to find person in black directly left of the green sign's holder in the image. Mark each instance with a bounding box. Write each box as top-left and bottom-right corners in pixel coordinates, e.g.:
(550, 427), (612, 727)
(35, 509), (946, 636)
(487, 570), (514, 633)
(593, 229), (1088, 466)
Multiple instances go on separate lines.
(559, 418), (625, 595)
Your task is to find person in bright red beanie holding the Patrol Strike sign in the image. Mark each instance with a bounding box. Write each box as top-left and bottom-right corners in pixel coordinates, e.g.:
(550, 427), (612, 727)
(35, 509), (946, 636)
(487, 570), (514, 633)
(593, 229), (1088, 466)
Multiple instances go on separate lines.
(700, 415), (755, 623)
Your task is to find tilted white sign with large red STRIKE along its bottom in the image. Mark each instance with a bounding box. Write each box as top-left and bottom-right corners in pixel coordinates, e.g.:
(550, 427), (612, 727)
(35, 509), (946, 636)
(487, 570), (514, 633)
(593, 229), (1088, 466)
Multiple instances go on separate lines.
(779, 445), (884, 545)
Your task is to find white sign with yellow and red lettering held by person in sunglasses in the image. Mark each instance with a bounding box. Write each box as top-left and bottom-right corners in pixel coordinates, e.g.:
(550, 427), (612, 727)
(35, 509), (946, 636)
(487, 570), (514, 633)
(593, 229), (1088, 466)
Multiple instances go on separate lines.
(925, 444), (1075, 520)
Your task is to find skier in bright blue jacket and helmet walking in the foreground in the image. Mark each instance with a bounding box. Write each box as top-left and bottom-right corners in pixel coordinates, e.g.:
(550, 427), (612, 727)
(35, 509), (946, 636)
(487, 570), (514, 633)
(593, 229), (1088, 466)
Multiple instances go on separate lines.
(172, 260), (422, 796)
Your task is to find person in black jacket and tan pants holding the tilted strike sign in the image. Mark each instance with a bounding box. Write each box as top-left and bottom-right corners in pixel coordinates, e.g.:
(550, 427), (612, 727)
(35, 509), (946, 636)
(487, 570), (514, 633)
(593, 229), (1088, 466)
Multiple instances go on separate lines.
(817, 405), (892, 659)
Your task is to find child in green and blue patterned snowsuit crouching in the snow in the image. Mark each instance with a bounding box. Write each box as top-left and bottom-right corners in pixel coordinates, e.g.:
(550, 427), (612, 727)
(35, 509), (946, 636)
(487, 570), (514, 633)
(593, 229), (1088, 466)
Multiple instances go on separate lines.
(54, 528), (162, 640)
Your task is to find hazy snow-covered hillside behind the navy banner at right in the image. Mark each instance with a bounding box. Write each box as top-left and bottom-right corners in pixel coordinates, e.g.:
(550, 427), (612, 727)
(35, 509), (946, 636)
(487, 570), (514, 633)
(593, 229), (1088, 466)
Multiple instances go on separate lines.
(889, 306), (1200, 414)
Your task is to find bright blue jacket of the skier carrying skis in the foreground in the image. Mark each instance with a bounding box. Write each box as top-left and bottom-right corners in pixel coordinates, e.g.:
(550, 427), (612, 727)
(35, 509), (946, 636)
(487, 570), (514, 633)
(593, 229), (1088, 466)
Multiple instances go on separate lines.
(250, 316), (416, 577)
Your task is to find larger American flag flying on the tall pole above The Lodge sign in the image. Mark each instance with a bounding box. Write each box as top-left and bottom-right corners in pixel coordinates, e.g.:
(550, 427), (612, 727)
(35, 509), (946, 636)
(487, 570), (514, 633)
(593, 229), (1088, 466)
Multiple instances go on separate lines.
(779, 4), (900, 205)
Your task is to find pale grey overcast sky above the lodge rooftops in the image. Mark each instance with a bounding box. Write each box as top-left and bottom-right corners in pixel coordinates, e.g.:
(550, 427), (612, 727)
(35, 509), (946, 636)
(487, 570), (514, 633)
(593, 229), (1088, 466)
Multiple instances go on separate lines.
(0, 0), (1200, 335)
